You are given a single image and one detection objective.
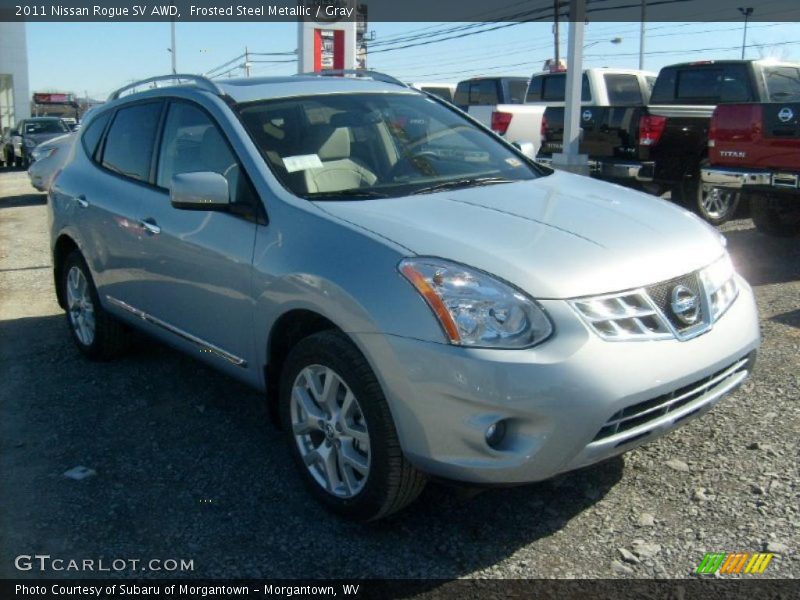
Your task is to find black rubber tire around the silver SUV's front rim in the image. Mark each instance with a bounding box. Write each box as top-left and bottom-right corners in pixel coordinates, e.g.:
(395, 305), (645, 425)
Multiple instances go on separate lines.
(279, 331), (397, 521)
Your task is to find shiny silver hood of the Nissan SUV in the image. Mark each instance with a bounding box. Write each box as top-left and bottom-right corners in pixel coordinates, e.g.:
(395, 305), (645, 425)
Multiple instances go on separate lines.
(316, 172), (724, 298)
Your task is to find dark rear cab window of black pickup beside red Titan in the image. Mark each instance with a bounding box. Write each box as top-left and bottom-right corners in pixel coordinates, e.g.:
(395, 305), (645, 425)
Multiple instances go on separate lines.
(651, 64), (754, 105)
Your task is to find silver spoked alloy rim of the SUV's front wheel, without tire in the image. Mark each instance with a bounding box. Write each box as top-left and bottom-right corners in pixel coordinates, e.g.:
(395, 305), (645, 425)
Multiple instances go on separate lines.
(290, 365), (371, 498)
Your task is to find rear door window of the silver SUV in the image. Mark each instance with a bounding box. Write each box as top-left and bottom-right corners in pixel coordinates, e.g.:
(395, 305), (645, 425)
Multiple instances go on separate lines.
(103, 102), (161, 181)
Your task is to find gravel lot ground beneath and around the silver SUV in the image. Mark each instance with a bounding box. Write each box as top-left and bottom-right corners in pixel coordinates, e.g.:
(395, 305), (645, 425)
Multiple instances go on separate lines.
(0, 172), (800, 578)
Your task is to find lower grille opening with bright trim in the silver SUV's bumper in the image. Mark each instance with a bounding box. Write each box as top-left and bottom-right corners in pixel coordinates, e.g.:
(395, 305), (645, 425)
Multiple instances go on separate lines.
(592, 358), (749, 445)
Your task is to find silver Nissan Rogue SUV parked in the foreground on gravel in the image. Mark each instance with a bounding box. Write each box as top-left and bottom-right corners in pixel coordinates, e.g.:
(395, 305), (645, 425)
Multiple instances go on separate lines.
(48, 74), (759, 520)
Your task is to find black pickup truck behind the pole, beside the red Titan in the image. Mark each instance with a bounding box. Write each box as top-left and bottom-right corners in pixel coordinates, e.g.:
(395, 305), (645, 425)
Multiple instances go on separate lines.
(539, 60), (796, 225)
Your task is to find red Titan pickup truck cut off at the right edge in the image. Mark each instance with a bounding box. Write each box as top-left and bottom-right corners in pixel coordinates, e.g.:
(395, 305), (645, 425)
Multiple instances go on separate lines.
(701, 97), (800, 236)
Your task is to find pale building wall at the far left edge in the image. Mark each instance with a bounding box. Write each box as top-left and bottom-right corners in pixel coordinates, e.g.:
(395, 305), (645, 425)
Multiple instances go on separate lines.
(0, 22), (31, 129)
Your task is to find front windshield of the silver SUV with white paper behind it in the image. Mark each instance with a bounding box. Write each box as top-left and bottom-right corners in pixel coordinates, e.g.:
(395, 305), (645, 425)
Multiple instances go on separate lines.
(240, 94), (539, 199)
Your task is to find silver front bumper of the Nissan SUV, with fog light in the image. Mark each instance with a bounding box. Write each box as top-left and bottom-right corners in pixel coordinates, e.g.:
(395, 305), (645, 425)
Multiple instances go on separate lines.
(355, 280), (759, 484)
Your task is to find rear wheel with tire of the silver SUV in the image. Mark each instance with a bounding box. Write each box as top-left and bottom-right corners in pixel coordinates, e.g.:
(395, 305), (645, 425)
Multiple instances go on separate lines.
(60, 250), (128, 360)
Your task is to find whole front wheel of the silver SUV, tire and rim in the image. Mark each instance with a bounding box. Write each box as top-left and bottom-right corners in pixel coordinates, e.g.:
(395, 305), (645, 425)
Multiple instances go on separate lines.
(279, 330), (426, 521)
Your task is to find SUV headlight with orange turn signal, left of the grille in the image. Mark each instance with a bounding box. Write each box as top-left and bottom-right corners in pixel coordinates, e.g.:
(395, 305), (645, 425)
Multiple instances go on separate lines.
(398, 258), (553, 349)
